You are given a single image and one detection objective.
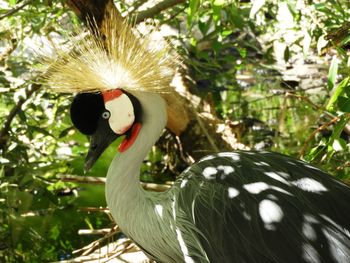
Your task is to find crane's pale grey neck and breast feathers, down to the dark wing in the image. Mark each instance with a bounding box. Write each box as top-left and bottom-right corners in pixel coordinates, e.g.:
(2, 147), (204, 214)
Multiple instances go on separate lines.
(106, 92), (208, 263)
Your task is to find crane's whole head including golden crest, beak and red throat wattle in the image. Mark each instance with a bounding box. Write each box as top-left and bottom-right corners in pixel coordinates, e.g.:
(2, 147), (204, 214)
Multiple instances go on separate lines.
(43, 12), (176, 170)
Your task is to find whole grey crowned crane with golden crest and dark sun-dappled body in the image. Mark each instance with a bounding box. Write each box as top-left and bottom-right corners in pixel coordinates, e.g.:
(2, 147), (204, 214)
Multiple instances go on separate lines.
(46, 12), (350, 263)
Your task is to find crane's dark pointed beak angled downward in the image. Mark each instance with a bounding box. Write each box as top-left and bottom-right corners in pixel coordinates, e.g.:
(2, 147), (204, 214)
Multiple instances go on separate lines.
(84, 121), (119, 173)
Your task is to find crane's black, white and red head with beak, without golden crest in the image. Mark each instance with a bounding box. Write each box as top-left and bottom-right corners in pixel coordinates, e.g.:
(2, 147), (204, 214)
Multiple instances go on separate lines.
(70, 89), (142, 171)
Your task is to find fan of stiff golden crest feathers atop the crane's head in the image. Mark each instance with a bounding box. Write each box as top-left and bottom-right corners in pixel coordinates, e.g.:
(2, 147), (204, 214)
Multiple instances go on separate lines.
(43, 10), (176, 93)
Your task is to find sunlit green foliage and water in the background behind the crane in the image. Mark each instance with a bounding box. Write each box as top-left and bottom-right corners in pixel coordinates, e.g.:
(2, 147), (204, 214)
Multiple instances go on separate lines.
(0, 0), (350, 262)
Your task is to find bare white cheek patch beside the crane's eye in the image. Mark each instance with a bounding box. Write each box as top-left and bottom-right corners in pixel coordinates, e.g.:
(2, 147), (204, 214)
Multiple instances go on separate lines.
(105, 94), (135, 134)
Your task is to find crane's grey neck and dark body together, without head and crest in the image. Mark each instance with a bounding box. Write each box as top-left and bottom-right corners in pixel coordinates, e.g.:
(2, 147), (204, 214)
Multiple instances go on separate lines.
(106, 92), (350, 263)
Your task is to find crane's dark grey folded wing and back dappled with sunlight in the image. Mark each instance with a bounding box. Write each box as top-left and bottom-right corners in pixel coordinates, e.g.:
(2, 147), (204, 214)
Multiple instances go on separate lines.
(175, 152), (350, 263)
